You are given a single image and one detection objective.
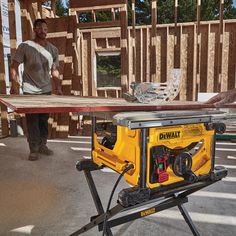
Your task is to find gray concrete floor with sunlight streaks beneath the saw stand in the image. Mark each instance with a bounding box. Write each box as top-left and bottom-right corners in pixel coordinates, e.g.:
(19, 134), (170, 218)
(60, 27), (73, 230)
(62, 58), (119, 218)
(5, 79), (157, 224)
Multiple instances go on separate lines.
(0, 137), (236, 236)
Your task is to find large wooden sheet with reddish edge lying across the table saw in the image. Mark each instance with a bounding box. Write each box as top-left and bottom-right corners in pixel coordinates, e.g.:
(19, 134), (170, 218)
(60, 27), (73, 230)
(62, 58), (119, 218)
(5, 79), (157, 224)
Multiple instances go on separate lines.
(0, 95), (233, 113)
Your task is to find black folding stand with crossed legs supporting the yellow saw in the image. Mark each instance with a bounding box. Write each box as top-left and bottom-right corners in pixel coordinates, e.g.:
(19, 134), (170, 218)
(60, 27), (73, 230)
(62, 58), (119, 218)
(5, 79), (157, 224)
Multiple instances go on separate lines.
(70, 160), (227, 236)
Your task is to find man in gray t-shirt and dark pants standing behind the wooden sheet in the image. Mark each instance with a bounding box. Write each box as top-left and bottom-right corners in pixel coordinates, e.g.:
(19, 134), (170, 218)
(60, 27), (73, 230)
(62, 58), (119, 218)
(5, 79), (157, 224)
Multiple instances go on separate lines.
(10, 19), (62, 161)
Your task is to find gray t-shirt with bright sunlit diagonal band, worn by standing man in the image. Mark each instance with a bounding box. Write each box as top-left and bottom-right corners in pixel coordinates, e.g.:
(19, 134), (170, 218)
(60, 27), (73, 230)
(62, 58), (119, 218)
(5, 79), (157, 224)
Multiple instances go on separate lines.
(13, 40), (59, 94)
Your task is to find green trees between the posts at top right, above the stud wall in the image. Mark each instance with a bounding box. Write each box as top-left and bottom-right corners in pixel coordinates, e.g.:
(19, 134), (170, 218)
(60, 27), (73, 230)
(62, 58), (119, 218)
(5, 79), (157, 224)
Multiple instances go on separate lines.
(136, 0), (236, 25)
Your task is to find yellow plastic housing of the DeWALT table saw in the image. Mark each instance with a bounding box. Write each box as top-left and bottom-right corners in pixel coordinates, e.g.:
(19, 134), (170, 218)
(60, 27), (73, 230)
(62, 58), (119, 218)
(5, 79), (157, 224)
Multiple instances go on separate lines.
(92, 123), (214, 188)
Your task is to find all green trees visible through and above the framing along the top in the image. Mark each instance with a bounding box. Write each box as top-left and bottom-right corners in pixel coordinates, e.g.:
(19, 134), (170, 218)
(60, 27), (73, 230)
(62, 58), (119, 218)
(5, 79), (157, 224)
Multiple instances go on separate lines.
(64, 0), (236, 25)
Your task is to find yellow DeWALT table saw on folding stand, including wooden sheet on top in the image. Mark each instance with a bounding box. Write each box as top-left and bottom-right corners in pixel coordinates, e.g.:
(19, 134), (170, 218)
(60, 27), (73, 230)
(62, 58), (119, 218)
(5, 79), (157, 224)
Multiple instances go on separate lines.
(0, 95), (236, 235)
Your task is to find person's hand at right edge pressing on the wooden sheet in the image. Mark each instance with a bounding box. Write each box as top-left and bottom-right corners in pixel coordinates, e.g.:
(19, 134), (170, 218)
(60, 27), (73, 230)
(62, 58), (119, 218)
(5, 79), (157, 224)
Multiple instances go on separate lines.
(206, 89), (236, 107)
